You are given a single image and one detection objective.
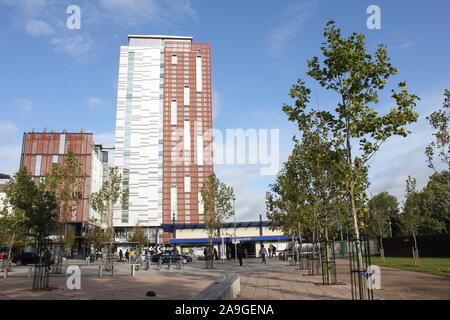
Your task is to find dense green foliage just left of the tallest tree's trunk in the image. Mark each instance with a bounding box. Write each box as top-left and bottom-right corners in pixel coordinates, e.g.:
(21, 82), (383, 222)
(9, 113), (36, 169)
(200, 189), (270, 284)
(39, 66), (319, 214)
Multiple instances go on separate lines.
(266, 117), (348, 239)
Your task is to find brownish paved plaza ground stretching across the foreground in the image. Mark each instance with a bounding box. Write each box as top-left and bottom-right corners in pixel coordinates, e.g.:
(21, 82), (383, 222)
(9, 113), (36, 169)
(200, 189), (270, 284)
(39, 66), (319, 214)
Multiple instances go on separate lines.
(0, 259), (450, 300)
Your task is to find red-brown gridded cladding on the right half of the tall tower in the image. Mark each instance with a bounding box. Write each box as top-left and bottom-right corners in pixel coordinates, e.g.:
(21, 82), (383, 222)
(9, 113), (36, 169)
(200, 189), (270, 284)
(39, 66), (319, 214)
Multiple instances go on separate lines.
(163, 41), (213, 225)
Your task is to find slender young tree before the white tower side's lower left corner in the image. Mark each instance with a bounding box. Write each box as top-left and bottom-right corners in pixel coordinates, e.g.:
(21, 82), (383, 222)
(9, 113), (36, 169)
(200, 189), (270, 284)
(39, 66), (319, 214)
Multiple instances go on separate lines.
(90, 167), (129, 255)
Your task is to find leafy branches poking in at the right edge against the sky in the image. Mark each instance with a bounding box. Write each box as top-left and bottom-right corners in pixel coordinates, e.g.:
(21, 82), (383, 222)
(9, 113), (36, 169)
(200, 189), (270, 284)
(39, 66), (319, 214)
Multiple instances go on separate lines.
(425, 89), (450, 172)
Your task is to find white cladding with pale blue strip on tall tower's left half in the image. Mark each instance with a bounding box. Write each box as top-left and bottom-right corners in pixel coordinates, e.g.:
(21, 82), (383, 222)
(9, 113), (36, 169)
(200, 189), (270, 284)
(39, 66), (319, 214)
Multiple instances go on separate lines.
(114, 45), (163, 227)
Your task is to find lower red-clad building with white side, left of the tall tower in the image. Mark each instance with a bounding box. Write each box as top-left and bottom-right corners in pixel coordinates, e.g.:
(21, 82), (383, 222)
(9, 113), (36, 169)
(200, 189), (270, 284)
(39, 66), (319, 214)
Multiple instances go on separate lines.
(20, 132), (108, 254)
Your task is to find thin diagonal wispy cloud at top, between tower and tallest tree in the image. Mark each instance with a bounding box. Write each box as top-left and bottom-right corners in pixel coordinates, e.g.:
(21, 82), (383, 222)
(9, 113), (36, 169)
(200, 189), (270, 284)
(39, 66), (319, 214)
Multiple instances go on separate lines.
(267, 1), (317, 57)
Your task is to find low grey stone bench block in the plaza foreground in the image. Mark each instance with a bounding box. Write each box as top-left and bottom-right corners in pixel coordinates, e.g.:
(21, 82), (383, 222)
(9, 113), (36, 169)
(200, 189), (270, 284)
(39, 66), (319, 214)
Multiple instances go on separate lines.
(191, 273), (241, 300)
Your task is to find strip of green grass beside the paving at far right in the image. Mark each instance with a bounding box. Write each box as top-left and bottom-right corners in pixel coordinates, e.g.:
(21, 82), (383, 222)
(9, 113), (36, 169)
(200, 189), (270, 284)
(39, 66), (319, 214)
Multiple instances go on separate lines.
(370, 257), (450, 278)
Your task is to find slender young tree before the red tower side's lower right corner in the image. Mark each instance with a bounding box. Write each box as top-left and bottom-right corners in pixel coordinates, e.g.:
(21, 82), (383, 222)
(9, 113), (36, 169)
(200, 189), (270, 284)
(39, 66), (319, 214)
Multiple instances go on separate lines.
(200, 173), (234, 268)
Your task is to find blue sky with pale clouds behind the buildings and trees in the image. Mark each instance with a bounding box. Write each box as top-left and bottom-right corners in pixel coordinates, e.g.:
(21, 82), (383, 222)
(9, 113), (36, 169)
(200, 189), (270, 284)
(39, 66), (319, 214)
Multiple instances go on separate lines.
(0, 0), (450, 220)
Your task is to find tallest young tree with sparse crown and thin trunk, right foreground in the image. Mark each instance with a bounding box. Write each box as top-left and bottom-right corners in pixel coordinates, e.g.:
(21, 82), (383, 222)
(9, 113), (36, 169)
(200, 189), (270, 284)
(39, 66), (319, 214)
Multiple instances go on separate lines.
(283, 20), (419, 292)
